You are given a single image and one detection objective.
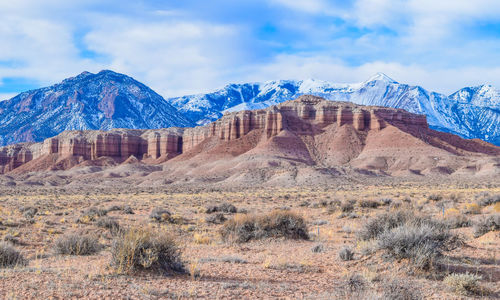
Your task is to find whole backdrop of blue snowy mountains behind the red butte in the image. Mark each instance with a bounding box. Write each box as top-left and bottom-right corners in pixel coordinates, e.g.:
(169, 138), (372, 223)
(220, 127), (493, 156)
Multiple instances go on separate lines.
(0, 70), (500, 145)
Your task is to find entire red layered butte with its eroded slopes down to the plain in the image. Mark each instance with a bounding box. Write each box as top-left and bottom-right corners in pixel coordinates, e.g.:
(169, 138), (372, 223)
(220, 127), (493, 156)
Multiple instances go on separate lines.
(0, 95), (500, 182)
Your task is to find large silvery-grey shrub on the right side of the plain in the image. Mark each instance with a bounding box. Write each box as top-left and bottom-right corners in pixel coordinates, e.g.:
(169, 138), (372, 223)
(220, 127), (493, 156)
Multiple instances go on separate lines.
(358, 211), (455, 269)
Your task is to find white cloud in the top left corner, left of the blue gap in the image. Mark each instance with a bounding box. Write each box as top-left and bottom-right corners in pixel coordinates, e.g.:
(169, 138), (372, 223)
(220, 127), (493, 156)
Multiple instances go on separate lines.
(0, 0), (102, 84)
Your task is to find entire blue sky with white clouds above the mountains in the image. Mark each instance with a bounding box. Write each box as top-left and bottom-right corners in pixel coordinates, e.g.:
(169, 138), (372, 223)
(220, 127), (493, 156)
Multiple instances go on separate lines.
(0, 0), (500, 99)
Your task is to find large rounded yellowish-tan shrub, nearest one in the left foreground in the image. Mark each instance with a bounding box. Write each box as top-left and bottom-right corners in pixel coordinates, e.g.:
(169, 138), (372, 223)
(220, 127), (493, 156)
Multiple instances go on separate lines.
(111, 228), (185, 274)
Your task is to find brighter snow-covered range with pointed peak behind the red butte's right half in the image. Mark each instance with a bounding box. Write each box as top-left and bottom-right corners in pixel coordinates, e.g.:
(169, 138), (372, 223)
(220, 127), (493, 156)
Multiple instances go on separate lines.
(167, 73), (500, 145)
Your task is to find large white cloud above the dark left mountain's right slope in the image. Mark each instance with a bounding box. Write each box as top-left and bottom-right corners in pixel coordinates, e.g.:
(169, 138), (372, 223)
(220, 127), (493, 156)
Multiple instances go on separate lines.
(85, 18), (245, 96)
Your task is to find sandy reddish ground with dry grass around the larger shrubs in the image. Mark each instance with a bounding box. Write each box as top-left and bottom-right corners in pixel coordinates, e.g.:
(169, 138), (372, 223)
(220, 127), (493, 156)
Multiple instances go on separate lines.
(0, 179), (500, 299)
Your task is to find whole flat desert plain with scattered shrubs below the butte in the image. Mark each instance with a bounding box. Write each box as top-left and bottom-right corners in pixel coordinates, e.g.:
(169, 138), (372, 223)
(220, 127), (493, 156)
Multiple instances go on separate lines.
(0, 185), (500, 299)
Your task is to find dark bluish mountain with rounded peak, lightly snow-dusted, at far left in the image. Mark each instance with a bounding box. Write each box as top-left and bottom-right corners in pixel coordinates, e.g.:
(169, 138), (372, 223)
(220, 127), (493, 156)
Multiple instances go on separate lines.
(0, 70), (194, 145)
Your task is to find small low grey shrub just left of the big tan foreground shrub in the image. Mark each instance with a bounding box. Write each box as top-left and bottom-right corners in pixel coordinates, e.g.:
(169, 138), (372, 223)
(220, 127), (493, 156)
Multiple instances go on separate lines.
(54, 233), (101, 255)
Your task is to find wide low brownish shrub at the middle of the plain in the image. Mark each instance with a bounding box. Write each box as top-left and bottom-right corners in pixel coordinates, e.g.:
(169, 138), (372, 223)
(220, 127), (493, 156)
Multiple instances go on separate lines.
(220, 210), (309, 242)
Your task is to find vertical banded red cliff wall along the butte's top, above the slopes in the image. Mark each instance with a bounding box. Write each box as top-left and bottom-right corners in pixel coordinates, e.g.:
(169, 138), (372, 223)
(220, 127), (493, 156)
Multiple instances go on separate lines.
(0, 95), (458, 173)
